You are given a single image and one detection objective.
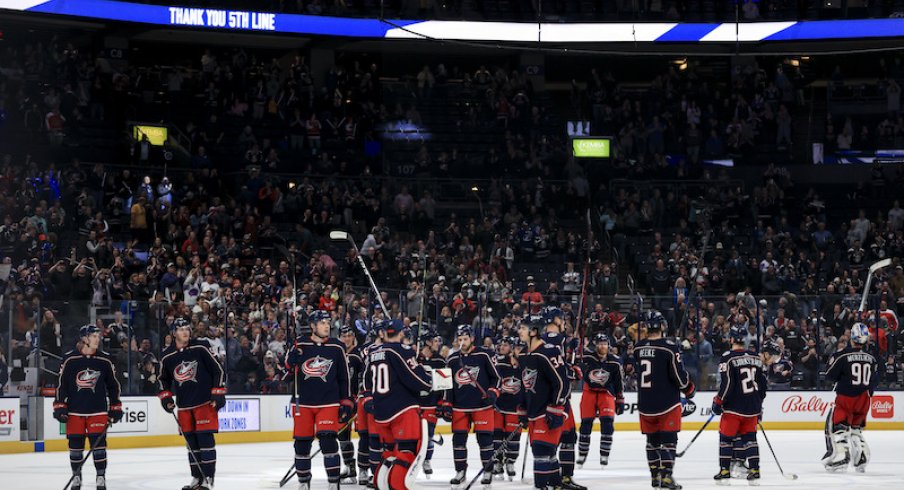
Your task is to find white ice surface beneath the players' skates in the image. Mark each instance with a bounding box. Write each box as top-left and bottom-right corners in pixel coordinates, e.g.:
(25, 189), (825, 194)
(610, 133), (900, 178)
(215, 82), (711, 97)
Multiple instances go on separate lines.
(0, 430), (904, 490)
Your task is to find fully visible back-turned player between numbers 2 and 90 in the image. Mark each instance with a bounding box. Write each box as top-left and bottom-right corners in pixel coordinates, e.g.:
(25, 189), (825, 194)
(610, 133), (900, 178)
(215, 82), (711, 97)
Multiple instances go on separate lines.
(712, 325), (766, 485)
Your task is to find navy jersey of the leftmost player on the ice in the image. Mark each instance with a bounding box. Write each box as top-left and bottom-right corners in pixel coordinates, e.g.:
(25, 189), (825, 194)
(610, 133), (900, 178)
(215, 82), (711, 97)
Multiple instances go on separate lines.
(54, 350), (121, 415)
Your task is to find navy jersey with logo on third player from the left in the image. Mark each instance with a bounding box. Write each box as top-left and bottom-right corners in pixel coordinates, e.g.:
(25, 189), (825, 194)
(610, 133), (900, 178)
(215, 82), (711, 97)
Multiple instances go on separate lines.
(286, 337), (351, 407)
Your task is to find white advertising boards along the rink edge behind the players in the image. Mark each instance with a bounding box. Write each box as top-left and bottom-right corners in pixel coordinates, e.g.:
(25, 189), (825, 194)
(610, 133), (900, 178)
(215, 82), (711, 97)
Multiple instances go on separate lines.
(0, 391), (904, 454)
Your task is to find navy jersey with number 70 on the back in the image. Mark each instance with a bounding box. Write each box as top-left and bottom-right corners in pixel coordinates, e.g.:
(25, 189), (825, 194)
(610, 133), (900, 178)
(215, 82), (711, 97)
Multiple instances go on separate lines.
(368, 342), (432, 423)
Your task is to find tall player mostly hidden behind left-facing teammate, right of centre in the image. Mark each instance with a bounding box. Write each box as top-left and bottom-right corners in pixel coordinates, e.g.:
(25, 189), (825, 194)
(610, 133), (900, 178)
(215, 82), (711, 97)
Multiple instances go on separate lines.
(542, 306), (587, 490)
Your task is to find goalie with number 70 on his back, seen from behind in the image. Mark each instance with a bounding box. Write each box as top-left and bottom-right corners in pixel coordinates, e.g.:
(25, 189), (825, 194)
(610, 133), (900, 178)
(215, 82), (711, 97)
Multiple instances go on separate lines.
(369, 320), (432, 490)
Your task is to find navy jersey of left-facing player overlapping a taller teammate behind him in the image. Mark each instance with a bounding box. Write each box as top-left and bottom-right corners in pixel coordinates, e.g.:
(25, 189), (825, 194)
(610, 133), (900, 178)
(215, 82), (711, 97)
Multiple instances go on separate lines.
(518, 344), (570, 420)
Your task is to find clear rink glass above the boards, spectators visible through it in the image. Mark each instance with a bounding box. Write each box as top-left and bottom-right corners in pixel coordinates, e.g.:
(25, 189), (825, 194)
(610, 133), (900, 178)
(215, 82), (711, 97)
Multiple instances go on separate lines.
(0, 290), (904, 395)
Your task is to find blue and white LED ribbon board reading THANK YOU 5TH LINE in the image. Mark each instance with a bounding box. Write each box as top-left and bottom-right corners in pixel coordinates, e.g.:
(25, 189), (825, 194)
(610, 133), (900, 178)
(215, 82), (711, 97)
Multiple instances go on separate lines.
(0, 0), (904, 44)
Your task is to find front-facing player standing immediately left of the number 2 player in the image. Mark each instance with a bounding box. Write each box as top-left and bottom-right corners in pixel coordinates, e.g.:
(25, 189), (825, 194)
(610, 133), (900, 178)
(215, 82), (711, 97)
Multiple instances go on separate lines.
(577, 332), (625, 467)
